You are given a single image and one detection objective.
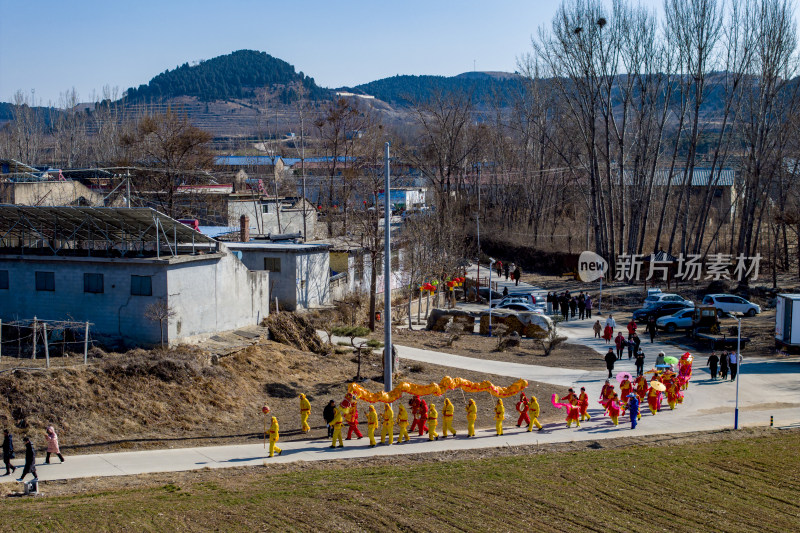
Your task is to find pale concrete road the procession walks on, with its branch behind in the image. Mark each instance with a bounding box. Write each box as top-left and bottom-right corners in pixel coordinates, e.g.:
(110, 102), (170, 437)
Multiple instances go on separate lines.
(0, 321), (800, 482)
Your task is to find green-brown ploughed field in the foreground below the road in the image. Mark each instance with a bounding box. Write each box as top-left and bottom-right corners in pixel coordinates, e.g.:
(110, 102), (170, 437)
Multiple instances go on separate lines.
(0, 431), (800, 532)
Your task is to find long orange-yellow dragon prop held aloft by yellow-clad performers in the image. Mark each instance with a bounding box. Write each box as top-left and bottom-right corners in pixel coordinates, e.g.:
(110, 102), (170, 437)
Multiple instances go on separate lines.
(348, 376), (528, 403)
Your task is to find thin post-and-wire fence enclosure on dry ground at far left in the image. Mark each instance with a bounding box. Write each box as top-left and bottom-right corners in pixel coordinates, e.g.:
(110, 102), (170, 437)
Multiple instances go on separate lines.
(0, 317), (91, 368)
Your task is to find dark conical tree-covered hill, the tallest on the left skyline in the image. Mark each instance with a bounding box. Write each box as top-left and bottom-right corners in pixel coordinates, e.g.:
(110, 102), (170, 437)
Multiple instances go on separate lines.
(126, 50), (329, 102)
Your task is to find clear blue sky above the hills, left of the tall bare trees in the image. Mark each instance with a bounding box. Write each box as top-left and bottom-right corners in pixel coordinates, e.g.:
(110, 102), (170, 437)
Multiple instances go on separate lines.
(0, 0), (680, 105)
